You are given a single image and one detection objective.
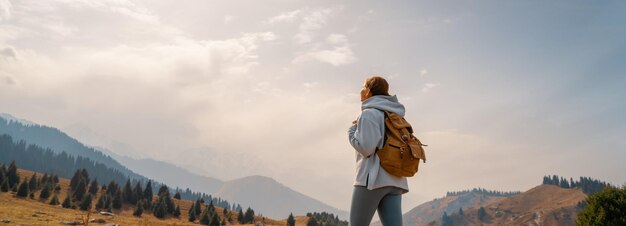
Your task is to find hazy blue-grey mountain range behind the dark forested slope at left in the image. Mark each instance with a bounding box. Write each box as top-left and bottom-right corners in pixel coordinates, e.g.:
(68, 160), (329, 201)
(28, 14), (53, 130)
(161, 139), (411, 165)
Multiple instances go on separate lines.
(0, 113), (348, 219)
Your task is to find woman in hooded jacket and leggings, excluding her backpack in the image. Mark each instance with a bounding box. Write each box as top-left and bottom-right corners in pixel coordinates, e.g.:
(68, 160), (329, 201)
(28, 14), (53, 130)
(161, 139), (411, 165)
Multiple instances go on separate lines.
(348, 76), (409, 226)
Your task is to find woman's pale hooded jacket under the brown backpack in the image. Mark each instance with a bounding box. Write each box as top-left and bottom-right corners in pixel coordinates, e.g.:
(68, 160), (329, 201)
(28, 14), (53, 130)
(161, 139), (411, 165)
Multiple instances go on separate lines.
(348, 95), (409, 193)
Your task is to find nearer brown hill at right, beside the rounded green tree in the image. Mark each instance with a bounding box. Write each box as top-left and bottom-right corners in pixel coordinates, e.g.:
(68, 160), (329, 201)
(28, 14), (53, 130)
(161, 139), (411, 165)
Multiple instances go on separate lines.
(430, 185), (587, 225)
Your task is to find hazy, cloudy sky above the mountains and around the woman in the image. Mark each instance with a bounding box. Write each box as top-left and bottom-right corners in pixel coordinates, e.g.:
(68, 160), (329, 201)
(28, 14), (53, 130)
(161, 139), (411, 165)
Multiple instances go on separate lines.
(0, 0), (626, 211)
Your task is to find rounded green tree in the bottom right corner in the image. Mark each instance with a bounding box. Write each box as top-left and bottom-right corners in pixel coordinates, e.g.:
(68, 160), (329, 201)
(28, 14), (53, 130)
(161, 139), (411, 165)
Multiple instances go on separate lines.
(576, 187), (626, 226)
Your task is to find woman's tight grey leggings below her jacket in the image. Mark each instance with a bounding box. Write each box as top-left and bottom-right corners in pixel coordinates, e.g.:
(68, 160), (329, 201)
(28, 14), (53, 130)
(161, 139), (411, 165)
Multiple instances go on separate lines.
(350, 186), (402, 226)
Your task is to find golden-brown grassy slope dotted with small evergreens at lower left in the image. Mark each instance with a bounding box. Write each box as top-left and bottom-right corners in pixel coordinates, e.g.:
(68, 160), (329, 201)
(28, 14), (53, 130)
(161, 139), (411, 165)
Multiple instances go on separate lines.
(0, 169), (288, 225)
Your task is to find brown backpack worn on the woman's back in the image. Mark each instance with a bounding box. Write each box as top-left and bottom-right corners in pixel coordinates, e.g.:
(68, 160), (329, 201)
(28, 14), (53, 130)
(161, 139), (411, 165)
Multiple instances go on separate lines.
(376, 111), (427, 177)
